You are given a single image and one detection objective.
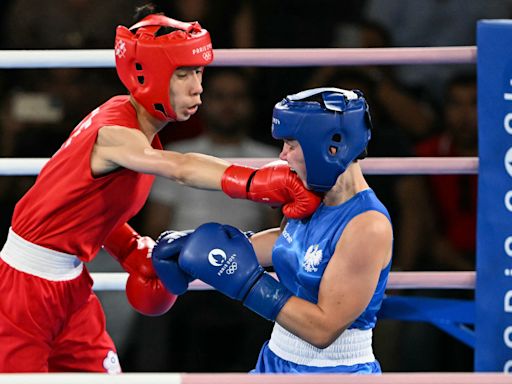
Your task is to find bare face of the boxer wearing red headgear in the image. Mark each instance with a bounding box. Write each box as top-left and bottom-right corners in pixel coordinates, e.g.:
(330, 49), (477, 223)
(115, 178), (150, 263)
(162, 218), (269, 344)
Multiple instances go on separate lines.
(169, 67), (204, 121)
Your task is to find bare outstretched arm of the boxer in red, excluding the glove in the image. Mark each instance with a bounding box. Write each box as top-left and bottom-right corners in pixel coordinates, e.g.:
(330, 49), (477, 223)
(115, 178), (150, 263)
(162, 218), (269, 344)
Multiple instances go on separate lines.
(91, 126), (230, 190)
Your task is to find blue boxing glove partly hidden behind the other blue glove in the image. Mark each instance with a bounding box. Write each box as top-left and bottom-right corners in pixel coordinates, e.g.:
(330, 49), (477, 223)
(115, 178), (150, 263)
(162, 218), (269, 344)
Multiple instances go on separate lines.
(151, 230), (194, 295)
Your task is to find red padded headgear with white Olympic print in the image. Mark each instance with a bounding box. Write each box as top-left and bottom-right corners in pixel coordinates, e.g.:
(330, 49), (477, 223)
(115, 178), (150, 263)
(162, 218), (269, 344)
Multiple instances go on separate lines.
(115, 14), (213, 121)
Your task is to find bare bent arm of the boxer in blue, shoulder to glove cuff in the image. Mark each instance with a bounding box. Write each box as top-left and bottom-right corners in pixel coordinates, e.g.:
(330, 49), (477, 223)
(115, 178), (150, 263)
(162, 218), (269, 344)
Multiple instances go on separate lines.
(276, 211), (392, 348)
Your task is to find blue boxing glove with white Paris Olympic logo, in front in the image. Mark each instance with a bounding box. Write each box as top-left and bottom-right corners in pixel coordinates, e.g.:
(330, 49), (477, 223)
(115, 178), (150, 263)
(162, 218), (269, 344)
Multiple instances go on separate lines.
(179, 223), (292, 320)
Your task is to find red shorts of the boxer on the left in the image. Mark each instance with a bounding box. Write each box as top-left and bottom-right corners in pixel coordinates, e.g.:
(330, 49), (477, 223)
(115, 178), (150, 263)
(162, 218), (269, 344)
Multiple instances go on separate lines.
(0, 259), (121, 373)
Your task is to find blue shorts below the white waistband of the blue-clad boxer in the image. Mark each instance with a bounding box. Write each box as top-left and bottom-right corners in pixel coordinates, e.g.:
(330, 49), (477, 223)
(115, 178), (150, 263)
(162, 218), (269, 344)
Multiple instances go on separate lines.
(249, 341), (382, 375)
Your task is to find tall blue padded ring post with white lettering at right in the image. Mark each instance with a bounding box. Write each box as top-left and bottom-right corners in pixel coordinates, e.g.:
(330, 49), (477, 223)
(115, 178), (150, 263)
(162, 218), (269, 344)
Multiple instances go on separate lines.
(475, 20), (512, 372)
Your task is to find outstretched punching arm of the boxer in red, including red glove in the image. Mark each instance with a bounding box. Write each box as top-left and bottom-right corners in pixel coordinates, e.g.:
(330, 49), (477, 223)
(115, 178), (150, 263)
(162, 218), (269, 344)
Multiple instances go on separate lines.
(91, 127), (320, 219)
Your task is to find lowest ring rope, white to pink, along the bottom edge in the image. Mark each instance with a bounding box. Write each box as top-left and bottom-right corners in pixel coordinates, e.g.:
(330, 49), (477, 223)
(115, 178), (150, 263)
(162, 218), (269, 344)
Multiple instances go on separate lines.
(0, 372), (512, 384)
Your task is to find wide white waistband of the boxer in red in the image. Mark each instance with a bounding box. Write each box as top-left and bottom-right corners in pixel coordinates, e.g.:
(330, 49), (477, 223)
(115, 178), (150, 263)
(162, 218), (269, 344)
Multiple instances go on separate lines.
(0, 228), (84, 281)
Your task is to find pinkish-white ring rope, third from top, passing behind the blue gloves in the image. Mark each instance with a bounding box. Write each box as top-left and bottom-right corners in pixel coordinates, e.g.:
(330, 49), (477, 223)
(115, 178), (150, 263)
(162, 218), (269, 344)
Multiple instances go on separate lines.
(91, 271), (476, 291)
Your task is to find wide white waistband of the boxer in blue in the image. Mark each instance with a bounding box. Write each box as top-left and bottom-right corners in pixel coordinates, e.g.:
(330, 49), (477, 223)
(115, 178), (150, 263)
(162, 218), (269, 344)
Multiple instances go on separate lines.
(268, 323), (375, 367)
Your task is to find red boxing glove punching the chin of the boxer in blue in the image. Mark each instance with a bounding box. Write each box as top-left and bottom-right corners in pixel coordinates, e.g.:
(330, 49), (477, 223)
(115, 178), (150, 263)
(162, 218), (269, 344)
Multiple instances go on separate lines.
(221, 162), (321, 219)
